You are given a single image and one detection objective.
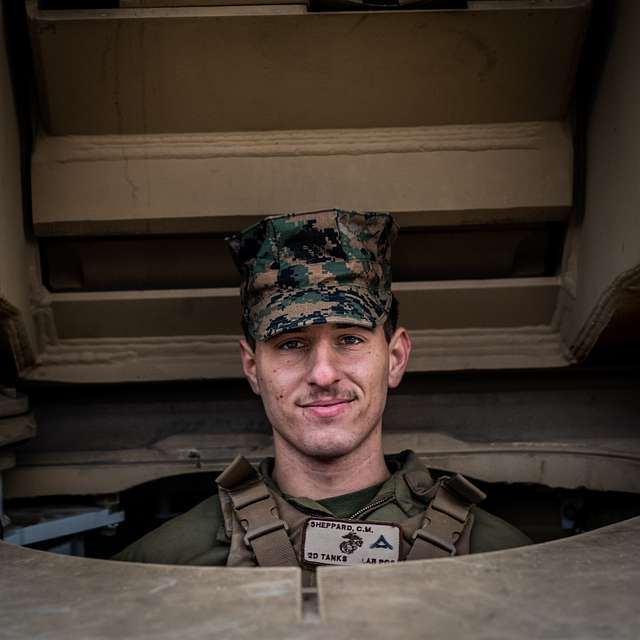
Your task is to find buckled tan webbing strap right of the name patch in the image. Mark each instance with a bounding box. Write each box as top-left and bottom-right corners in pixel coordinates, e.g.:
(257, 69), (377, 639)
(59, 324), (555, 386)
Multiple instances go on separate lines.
(406, 474), (486, 560)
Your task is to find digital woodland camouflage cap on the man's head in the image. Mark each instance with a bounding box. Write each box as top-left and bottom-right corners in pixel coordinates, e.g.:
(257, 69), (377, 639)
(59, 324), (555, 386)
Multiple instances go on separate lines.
(227, 209), (398, 340)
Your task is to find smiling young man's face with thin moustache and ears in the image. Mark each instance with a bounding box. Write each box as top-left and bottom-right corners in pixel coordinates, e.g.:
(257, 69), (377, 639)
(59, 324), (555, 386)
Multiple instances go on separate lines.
(242, 324), (411, 459)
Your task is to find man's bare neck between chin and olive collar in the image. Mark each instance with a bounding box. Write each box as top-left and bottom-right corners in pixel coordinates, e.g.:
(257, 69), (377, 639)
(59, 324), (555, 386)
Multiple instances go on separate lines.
(273, 431), (390, 500)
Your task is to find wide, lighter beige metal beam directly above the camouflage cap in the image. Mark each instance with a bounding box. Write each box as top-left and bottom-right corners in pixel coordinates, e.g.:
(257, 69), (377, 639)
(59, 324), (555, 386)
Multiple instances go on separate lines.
(32, 122), (573, 235)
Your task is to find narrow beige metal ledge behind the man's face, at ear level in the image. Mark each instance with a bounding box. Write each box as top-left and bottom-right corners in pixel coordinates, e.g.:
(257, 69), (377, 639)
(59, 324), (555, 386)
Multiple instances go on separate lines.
(24, 326), (571, 384)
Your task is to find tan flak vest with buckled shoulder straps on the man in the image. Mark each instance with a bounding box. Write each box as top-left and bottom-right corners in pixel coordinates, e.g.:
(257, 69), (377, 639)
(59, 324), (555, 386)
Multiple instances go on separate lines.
(216, 452), (485, 567)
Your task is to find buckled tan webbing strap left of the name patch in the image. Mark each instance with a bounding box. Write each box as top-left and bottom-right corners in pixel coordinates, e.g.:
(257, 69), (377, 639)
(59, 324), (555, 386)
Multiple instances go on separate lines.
(216, 456), (300, 567)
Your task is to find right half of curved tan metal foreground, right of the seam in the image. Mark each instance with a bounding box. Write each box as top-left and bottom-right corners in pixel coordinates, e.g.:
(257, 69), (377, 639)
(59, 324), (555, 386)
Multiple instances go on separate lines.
(318, 518), (640, 640)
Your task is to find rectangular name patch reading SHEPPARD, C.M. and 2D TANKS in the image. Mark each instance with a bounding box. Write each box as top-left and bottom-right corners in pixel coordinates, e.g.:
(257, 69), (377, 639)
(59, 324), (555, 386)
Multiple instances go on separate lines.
(303, 518), (400, 565)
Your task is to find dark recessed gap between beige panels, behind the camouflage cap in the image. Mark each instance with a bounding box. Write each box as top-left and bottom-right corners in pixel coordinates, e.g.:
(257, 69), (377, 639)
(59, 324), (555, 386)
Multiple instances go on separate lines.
(40, 223), (564, 292)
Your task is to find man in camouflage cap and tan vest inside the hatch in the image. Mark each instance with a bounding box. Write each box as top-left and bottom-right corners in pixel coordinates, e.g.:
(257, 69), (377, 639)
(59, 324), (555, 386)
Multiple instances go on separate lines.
(116, 210), (530, 570)
